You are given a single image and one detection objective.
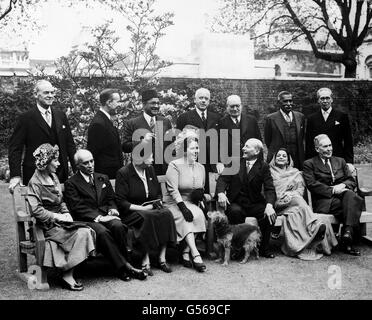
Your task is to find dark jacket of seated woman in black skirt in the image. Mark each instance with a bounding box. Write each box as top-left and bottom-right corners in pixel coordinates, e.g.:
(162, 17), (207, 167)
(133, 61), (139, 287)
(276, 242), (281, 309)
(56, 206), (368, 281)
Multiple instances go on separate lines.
(115, 163), (162, 216)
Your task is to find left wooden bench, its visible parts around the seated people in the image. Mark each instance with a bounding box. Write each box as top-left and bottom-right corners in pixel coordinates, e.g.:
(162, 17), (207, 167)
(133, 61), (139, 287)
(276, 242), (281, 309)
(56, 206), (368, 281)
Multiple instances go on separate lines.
(12, 176), (213, 290)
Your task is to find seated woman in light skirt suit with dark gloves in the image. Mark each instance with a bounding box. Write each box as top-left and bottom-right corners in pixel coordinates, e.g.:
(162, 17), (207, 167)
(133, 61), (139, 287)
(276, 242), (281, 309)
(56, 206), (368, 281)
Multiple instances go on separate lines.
(165, 129), (206, 272)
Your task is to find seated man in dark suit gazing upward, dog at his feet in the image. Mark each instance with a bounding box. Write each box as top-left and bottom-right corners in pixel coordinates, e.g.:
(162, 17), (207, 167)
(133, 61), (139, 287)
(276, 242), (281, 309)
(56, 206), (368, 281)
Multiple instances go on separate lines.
(216, 138), (276, 258)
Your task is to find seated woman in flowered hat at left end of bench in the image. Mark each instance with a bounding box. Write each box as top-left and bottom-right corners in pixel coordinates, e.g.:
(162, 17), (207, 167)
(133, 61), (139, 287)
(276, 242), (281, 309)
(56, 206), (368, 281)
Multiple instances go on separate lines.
(27, 143), (95, 291)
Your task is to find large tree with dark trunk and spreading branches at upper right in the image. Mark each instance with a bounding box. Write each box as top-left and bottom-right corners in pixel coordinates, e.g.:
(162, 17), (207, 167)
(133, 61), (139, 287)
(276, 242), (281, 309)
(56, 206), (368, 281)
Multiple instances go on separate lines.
(212, 0), (372, 78)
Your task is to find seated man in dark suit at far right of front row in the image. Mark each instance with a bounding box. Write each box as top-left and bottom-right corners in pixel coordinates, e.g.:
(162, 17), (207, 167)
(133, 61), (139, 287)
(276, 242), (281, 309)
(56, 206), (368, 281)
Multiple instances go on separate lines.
(303, 134), (363, 256)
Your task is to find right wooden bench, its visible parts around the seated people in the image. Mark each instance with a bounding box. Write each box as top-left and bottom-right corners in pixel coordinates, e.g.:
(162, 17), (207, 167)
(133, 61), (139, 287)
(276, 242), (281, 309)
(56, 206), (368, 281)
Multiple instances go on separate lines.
(209, 169), (372, 244)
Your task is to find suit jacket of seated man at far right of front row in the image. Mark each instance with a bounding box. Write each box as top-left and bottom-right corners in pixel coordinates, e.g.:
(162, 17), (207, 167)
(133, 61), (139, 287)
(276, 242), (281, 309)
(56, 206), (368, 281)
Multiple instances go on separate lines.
(303, 156), (356, 213)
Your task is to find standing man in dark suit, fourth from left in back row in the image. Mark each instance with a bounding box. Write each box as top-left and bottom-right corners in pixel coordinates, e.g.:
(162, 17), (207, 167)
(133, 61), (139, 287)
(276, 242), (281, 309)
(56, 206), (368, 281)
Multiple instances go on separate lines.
(177, 88), (223, 193)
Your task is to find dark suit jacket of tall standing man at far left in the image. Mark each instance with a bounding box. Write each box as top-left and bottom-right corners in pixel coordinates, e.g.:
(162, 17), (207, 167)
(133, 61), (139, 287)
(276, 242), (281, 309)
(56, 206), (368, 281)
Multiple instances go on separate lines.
(8, 107), (76, 184)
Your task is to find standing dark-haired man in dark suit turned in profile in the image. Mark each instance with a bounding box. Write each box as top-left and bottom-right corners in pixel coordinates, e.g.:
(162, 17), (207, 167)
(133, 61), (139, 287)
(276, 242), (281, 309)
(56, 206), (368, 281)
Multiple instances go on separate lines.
(87, 89), (123, 179)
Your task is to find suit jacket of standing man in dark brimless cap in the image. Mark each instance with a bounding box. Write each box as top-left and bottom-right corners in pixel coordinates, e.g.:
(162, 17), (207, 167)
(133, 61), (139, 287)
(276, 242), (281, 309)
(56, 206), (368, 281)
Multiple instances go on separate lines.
(122, 114), (172, 174)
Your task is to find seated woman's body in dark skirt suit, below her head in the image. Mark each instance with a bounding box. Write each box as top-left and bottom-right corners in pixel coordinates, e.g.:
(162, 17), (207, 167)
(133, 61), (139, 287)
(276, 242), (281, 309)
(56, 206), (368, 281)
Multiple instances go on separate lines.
(115, 154), (177, 276)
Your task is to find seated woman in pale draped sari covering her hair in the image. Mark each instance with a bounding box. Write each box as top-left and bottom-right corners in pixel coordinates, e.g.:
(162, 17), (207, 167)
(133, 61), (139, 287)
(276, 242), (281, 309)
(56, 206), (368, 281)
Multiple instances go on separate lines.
(270, 148), (337, 260)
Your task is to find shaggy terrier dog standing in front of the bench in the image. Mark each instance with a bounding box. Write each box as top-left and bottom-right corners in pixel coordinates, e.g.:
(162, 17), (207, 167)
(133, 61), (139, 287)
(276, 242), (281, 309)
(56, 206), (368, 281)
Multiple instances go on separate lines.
(207, 211), (261, 266)
